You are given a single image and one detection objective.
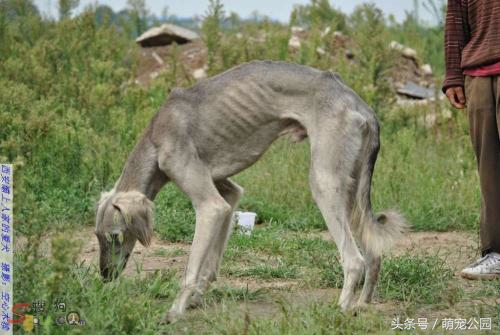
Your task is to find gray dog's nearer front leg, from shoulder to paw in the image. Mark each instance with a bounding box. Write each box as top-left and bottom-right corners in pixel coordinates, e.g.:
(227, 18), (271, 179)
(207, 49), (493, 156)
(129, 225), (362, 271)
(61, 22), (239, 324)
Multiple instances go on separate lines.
(159, 146), (232, 322)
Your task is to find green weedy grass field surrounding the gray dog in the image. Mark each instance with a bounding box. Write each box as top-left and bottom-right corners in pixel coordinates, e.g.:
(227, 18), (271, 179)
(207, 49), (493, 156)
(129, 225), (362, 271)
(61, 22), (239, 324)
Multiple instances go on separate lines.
(0, 0), (500, 335)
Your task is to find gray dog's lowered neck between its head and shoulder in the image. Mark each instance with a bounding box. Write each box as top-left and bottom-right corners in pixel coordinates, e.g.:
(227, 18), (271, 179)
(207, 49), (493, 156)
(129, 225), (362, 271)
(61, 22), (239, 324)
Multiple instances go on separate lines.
(115, 136), (168, 201)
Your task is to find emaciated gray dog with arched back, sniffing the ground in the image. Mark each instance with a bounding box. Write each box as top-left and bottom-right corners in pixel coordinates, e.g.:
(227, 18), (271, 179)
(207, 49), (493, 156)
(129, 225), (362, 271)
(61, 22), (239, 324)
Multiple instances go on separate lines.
(95, 61), (406, 322)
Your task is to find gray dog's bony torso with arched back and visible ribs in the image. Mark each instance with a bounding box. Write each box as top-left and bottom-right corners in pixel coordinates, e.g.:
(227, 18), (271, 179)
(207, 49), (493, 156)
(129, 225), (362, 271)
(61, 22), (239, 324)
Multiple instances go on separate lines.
(153, 61), (370, 179)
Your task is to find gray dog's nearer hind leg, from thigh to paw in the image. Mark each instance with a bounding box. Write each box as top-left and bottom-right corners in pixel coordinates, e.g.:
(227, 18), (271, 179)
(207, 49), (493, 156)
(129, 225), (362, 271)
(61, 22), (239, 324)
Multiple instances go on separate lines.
(308, 112), (365, 310)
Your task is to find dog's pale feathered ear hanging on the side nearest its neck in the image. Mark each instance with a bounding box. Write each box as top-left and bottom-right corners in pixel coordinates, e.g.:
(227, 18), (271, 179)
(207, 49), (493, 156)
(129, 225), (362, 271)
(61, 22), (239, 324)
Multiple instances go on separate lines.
(113, 191), (154, 247)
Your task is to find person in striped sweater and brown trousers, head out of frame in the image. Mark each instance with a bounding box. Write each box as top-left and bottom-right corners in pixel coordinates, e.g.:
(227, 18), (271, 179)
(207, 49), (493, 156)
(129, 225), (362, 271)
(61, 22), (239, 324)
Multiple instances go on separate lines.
(443, 0), (500, 279)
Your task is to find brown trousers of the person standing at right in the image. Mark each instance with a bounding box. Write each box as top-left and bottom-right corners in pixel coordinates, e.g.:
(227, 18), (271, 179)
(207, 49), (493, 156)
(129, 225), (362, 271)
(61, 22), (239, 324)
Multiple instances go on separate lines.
(465, 75), (500, 256)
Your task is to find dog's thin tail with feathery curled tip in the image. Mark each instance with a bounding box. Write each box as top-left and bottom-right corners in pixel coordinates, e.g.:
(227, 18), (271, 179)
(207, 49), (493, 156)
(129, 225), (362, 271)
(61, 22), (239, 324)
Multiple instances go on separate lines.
(351, 134), (409, 256)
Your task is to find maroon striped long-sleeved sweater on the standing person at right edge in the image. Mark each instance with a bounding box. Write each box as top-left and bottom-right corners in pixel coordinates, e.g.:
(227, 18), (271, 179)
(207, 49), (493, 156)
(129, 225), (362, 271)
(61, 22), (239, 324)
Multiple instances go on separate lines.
(443, 0), (500, 92)
